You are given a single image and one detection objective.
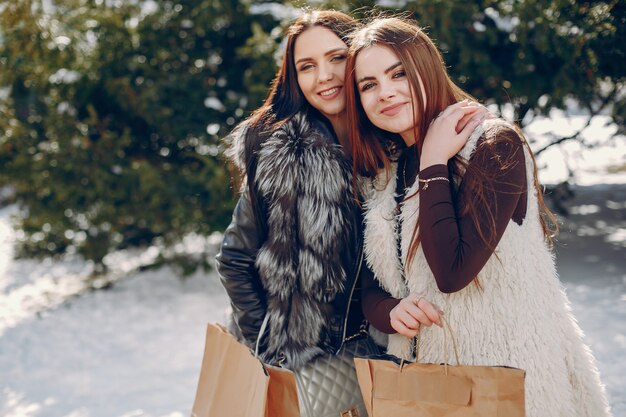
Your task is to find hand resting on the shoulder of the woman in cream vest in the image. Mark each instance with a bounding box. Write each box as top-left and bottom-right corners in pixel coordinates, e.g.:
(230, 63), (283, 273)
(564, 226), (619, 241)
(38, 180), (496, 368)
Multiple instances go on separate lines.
(420, 100), (490, 170)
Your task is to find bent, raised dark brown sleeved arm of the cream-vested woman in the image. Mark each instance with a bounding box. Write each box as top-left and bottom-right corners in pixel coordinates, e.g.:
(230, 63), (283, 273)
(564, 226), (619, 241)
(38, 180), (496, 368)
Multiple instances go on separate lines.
(419, 129), (526, 293)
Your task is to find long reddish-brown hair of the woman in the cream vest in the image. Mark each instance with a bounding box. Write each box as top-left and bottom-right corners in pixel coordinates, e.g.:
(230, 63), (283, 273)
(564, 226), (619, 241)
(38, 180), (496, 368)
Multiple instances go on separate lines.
(345, 17), (556, 267)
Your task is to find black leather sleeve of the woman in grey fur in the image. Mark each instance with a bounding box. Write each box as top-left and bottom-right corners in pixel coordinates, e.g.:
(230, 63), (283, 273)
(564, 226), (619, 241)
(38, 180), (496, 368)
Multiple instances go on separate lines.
(216, 191), (266, 345)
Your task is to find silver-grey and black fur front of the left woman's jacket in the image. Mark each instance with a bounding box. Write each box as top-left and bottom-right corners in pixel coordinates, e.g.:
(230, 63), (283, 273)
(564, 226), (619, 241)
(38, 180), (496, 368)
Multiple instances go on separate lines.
(230, 114), (356, 369)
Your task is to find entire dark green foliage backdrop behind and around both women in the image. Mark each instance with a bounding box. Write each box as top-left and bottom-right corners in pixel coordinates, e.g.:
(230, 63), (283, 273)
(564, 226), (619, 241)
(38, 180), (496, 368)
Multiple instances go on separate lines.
(0, 0), (626, 263)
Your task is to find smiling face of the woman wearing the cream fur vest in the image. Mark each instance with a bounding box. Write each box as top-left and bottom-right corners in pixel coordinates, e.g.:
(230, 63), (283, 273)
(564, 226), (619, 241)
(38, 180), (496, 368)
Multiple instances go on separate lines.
(355, 45), (426, 145)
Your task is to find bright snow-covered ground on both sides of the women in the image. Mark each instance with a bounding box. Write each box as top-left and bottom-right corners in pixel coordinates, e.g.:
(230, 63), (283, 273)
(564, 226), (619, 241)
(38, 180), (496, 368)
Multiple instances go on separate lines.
(0, 111), (626, 417)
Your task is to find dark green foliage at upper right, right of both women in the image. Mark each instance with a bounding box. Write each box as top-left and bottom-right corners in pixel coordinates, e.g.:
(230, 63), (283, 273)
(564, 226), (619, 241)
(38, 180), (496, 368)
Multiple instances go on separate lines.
(408, 0), (626, 134)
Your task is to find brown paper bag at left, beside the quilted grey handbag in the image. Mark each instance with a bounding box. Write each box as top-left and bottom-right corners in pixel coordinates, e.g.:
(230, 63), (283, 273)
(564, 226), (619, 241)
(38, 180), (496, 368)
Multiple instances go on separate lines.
(191, 324), (300, 417)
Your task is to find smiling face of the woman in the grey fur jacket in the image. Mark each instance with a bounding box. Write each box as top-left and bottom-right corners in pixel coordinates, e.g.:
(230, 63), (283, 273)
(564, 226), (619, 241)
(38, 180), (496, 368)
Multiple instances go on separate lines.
(294, 26), (348, 118)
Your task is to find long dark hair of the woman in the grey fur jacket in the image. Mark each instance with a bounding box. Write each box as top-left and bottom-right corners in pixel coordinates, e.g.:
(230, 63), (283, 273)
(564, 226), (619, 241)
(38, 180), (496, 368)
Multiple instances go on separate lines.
(235, 10), (358, 195)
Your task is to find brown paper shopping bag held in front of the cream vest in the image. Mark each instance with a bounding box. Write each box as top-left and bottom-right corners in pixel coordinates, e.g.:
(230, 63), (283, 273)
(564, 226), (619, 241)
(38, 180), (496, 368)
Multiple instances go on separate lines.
(354, 322), (525, 417)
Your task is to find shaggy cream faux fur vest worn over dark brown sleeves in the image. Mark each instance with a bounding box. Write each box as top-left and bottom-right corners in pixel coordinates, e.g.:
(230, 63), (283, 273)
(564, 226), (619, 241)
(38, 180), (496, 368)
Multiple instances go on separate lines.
(365, 119), (610, 417)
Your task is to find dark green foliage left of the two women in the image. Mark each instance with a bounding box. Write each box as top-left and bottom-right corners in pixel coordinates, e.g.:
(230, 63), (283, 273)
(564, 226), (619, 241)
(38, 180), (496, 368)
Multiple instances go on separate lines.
(0, 0), (275, 263)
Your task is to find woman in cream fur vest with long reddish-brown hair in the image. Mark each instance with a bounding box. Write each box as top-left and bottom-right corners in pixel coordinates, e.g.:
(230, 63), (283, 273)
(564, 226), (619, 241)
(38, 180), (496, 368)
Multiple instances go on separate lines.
(346, 18), (610, 417)
